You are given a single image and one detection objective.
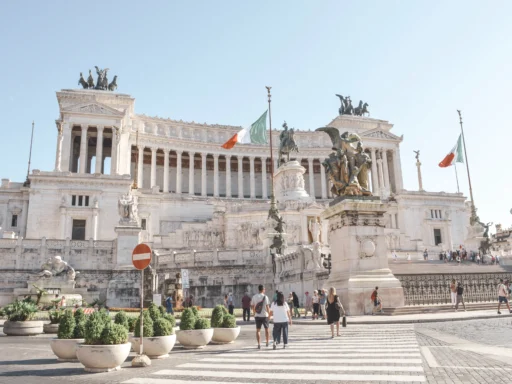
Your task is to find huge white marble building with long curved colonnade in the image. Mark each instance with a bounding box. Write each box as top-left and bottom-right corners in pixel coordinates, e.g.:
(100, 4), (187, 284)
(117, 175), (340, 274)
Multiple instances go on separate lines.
(0, 90), (469, 308)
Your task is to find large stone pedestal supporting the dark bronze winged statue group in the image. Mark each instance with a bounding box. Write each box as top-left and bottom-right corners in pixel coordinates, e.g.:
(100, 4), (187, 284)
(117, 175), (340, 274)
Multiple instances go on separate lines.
(322, 196), (404, 315)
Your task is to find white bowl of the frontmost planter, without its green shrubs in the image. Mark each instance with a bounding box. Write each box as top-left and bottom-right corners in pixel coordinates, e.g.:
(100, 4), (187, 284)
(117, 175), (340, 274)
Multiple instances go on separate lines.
(76, 343), (131, 372)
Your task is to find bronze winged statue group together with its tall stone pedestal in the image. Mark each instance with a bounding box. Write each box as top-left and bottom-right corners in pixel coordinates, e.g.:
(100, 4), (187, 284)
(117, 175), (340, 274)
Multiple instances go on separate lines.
(317, 127), (404, 315)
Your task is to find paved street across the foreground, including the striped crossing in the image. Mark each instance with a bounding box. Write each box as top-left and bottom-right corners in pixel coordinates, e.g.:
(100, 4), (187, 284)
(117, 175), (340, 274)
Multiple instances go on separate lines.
(0, 316), (512, 384)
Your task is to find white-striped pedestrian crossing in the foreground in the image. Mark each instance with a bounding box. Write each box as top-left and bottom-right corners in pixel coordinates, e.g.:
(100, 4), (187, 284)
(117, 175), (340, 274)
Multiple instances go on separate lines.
(124, 326), (426, 384)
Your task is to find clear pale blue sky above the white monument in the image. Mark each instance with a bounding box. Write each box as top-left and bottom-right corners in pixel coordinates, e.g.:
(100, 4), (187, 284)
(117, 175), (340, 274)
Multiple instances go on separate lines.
(0, 0), (512, 226)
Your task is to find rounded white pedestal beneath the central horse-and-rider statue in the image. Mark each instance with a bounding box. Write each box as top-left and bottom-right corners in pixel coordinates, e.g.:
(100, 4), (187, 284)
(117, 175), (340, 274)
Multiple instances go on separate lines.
(274, 160), (311, 202)
